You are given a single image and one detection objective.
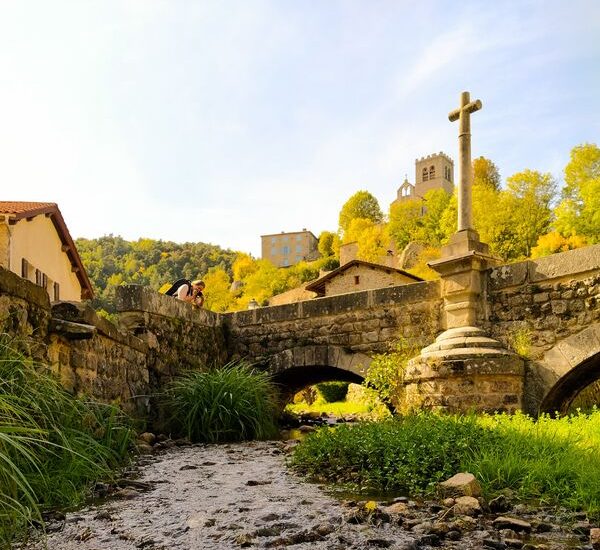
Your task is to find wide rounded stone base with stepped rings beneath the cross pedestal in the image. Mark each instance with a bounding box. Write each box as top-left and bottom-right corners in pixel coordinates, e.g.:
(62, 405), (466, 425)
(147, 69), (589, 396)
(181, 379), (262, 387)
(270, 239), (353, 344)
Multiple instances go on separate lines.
(403, 327), (524, 413)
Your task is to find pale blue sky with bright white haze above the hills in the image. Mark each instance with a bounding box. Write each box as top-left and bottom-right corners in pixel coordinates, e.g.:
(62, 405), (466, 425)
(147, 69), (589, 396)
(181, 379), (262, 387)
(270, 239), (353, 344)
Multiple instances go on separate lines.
(0, 0), (600, 257)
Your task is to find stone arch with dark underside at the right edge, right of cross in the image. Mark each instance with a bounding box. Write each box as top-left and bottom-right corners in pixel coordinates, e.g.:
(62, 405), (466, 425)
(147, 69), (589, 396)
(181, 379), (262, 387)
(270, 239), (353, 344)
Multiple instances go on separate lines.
(540, 323), (600, 414)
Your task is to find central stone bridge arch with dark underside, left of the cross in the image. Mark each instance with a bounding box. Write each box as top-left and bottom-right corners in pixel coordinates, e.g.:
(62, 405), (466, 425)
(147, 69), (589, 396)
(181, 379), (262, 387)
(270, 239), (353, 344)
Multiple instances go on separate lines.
(261, 345), (372, 401)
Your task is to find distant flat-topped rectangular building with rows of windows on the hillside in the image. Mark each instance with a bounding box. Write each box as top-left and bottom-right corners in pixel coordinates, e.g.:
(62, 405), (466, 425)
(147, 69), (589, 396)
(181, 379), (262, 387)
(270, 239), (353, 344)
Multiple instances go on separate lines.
(260, 229), (319, 267)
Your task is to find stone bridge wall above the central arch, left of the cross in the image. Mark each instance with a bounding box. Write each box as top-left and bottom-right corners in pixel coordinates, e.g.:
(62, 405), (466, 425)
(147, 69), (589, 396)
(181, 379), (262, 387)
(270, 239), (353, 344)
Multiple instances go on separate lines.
(225, 281), (441, 366)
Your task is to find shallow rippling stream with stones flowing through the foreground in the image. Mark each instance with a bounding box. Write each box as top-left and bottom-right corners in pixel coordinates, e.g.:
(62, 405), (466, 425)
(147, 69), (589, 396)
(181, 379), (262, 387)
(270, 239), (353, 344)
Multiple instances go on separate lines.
(21, 442), (420, 550)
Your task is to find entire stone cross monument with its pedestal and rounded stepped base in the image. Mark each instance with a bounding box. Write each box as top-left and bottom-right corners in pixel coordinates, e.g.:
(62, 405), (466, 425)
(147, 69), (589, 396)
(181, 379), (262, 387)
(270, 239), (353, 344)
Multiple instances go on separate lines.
(404, 92), (524, 412)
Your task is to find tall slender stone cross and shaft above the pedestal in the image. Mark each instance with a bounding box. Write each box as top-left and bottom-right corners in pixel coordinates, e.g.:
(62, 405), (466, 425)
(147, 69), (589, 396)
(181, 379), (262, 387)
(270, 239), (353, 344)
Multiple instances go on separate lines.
(448, 92), (481, 231)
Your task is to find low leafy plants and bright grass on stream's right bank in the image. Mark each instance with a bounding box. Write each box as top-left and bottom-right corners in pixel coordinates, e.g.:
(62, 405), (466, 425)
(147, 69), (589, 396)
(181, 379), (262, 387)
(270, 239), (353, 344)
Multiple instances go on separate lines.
(292, 411), (600, 517)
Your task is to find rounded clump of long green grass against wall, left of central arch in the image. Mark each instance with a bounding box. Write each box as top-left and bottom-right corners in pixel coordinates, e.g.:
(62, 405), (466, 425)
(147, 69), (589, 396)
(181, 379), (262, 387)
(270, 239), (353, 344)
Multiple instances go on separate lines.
(165, 362), (278, 443)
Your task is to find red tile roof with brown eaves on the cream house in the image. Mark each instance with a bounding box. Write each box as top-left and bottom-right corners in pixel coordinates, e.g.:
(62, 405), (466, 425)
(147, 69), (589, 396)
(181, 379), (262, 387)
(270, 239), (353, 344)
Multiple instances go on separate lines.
(0, 201), (94, 300)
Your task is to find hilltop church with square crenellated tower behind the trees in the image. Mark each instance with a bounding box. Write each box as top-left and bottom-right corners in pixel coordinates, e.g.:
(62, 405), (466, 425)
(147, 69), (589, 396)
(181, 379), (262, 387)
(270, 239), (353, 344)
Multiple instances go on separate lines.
(392, 152), (454, 208)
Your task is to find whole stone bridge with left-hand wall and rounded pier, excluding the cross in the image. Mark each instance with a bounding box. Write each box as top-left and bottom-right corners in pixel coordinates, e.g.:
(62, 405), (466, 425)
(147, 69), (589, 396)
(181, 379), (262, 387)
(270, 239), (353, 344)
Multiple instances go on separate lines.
(0, 245), (600, 415)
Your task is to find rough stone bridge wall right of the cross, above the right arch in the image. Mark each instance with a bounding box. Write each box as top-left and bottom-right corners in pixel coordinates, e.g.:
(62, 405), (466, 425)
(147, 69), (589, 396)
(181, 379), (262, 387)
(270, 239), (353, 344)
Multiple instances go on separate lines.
(483, 245), (600, 413)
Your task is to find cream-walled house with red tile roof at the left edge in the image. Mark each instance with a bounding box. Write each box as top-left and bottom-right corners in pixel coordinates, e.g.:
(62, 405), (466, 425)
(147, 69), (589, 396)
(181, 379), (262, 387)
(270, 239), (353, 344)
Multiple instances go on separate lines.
(0, 201), (94, 301)
